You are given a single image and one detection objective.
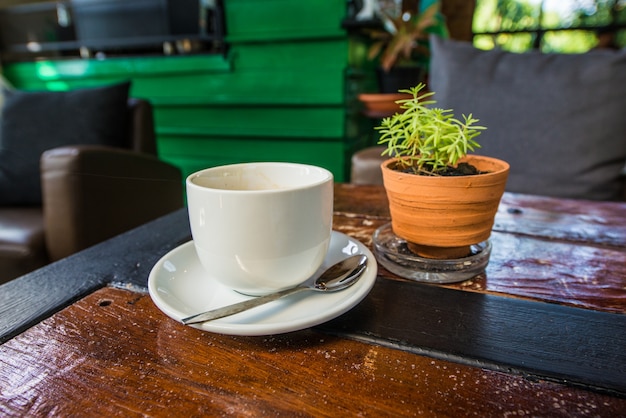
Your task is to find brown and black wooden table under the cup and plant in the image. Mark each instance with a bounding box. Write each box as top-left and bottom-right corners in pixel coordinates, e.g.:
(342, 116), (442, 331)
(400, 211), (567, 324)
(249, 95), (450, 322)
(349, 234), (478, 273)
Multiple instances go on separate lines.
(0, 184), (626, 417)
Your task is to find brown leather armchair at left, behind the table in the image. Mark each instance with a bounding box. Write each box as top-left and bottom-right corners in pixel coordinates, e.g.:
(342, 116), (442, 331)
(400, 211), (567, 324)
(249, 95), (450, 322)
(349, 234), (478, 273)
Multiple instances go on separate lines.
(0, 98), (183, 283)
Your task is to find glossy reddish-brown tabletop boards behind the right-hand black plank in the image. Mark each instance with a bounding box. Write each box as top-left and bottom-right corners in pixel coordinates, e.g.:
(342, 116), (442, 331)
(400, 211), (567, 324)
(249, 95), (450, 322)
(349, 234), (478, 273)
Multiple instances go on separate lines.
(334, 185), (626, 313)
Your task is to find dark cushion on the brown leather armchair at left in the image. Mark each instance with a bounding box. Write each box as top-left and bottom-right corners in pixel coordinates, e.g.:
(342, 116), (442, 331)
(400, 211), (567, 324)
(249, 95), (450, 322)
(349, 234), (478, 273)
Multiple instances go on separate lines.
(0, 82), (130, 205)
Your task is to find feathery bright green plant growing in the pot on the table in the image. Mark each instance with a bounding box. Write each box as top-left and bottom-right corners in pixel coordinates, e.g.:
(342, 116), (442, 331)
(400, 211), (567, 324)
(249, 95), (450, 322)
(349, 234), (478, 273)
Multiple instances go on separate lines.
(375, 83), (486, 175)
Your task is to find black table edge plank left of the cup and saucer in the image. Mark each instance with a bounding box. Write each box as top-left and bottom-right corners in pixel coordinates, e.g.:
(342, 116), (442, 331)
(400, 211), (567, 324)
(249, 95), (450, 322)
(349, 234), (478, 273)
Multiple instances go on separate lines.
(0, 209), (191, 344)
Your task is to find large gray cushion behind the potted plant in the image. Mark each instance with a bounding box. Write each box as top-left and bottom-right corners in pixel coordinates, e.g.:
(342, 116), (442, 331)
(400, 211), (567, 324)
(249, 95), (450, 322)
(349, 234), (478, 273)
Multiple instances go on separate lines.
(429, 37), (626, 200)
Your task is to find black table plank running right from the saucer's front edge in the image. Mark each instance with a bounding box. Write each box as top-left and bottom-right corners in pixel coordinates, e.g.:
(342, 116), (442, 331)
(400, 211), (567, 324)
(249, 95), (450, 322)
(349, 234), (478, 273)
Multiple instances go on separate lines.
(319, 278), (626, 395)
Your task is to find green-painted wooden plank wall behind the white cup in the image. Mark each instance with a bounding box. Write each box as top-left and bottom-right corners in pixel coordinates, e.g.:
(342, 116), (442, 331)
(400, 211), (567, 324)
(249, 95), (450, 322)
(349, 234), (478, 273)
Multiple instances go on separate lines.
(4, 0), (370, 181)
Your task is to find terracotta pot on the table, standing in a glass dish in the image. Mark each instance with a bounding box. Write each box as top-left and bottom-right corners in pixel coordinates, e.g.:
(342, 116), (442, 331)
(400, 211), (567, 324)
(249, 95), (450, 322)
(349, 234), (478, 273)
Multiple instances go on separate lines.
(381, 155), (509, 259)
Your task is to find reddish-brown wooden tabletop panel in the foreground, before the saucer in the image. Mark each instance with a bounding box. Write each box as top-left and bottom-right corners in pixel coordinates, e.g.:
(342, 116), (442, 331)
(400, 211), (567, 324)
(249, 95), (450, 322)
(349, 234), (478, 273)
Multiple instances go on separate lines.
(0, 288), (626, 417)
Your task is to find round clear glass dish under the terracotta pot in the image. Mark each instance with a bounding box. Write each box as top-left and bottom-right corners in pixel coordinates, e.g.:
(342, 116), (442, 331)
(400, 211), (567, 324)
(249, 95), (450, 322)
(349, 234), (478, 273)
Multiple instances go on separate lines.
(373, 223), (491, 283)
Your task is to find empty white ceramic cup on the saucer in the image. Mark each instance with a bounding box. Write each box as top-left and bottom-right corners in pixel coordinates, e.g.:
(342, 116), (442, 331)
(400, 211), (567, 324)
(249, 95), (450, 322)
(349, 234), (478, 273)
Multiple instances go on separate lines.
(186, 163), (333, 295)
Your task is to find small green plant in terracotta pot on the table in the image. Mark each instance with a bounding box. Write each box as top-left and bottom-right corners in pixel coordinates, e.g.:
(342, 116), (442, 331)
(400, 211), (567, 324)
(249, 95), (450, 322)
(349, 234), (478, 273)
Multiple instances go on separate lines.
(376, 83), (509, 259)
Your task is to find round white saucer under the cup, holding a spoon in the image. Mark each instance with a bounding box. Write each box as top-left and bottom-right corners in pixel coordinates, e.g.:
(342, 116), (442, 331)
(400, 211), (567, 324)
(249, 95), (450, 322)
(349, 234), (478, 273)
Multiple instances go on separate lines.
(148, 231), (378, 335)
